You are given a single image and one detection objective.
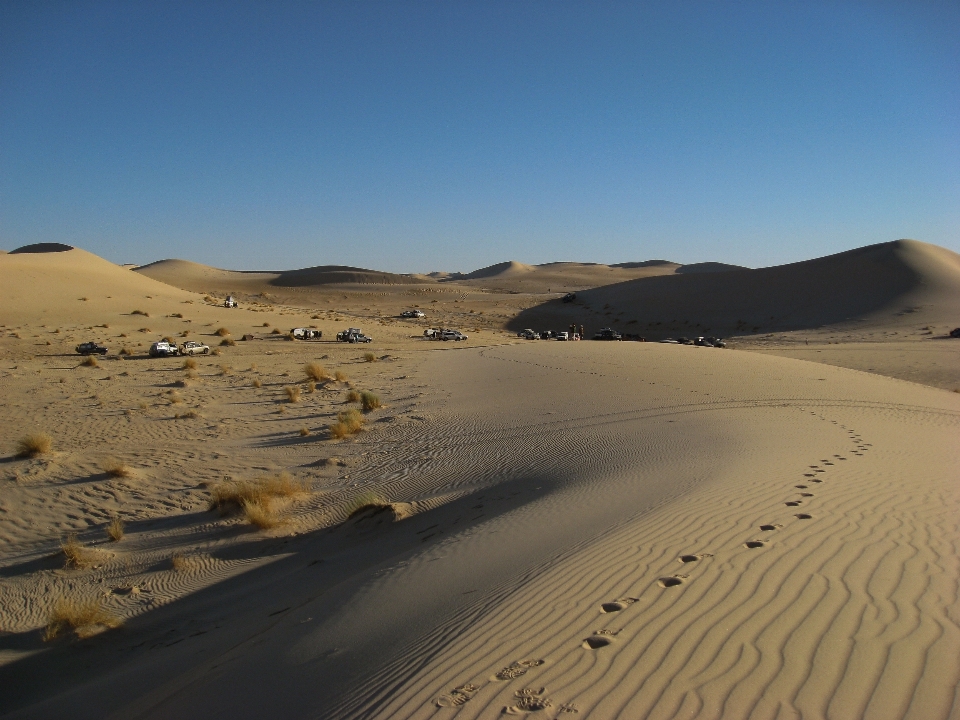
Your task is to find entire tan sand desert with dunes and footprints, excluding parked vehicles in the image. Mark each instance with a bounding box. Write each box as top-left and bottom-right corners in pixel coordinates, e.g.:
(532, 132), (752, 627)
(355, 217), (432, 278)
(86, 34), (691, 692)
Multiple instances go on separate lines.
(0, 240), (960, 720)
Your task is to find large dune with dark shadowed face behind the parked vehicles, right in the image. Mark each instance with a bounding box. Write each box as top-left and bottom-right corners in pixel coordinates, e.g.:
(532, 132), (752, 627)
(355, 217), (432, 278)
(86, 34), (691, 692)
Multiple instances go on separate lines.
(511, 240), (960, 337)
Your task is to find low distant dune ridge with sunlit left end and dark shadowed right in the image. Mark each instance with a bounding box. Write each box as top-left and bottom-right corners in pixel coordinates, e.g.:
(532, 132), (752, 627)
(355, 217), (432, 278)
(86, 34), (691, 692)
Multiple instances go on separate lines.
(136, 259), (424, 295)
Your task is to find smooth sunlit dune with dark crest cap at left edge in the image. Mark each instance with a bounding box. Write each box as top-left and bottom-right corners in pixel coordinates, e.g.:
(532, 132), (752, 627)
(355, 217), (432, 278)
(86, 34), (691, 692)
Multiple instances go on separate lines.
(0, 245), (191, 324)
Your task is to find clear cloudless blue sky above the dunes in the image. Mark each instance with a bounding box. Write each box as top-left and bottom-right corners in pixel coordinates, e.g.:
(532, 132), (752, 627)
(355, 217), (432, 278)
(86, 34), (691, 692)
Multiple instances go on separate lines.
(0, 0), (960, 272)
